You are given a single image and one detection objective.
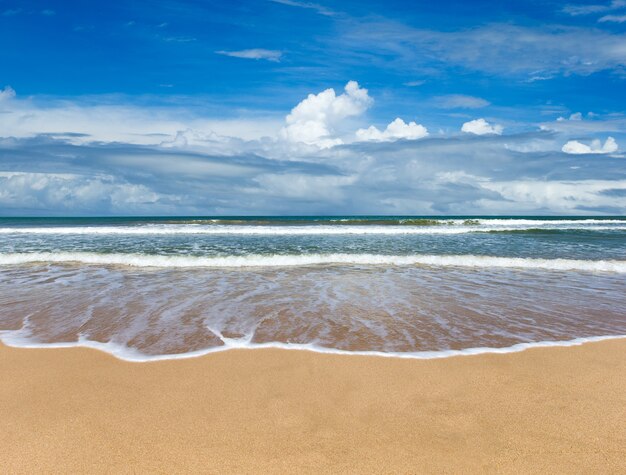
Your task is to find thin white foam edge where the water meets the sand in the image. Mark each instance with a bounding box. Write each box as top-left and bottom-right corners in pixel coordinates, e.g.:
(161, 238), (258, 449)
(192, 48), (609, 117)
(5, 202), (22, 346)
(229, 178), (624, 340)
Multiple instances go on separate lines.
(0, 330), (626, 363)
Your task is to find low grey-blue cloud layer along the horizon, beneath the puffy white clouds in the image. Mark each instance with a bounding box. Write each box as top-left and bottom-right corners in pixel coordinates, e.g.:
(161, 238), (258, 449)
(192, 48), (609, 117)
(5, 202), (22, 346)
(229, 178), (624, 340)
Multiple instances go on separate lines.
(0, 131), (626, 215)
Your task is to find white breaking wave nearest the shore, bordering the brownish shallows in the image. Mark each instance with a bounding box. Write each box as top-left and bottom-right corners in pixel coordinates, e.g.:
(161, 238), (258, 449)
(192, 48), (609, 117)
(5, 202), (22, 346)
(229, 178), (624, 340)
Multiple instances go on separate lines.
(0, 252), (626, 273)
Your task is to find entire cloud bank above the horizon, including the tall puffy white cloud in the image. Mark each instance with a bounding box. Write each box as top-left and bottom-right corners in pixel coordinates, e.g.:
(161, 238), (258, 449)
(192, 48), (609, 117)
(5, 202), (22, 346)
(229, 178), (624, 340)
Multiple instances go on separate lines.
(0, 81), (626, 215)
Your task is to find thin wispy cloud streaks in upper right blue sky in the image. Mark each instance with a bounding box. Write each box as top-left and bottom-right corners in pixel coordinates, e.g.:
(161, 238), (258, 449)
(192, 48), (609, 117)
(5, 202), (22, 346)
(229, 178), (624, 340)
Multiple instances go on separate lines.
(333, 20), (626, 80)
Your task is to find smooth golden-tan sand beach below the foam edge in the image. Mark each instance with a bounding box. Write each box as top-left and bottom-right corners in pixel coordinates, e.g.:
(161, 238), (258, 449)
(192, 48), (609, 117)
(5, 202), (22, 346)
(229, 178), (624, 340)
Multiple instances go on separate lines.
(0, 339), (626, 473)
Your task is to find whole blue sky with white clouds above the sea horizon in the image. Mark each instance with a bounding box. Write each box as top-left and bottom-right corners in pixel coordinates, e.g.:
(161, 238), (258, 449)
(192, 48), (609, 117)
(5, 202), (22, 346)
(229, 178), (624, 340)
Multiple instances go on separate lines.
(0, 0), (626, 216)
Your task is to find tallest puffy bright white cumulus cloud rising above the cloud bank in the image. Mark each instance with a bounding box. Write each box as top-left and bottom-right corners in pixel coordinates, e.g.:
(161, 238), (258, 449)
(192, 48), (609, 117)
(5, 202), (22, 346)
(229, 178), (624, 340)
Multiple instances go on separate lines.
(280, 81), (373, 148)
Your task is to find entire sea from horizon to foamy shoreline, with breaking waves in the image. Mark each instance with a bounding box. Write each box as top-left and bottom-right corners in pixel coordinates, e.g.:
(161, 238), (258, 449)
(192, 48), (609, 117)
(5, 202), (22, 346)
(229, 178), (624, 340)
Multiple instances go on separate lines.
(0, 216), (626, 361)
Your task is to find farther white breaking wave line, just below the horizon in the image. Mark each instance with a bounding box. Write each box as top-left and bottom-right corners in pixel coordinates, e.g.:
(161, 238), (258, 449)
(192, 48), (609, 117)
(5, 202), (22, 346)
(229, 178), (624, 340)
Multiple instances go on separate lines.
(0, 221), (626, 236)
